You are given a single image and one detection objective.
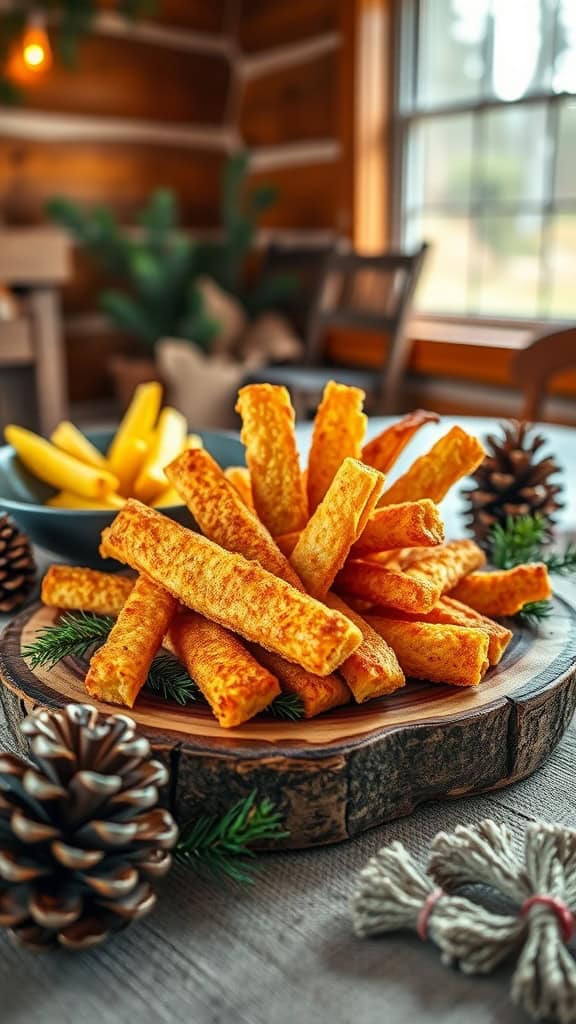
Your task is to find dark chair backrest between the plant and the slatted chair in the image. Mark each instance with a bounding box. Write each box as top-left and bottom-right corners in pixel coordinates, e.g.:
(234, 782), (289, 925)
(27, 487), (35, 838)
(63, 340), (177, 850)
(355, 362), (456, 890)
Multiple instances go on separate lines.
(262, 239), (338, 339)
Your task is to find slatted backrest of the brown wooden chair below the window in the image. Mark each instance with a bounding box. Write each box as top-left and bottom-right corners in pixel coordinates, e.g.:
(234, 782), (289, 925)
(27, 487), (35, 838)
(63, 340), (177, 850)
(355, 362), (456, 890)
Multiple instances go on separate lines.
(306, 243), (428, 403)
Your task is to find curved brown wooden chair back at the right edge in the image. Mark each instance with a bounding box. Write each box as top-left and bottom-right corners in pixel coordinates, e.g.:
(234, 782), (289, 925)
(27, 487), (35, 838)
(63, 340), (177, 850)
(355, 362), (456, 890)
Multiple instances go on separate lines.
(511, 326), (576, 421)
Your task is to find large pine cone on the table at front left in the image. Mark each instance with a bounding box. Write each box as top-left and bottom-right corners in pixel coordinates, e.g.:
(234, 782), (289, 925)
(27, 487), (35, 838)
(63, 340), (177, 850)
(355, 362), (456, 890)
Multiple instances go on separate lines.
(0, 705), (177, 950)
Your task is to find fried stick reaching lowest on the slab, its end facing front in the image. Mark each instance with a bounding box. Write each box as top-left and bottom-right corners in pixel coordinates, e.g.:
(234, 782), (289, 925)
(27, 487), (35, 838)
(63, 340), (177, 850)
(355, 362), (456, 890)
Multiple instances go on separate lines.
(166, 611), (280, 729)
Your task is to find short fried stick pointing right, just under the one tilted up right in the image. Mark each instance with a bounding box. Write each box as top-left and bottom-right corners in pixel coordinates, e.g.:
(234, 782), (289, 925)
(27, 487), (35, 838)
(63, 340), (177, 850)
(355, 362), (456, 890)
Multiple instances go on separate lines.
(353, 498), (444, 556)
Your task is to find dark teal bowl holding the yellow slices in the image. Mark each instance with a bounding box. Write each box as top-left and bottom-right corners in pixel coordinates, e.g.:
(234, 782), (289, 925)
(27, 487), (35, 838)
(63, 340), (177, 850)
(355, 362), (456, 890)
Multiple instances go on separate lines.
(0, 430), (244, 570)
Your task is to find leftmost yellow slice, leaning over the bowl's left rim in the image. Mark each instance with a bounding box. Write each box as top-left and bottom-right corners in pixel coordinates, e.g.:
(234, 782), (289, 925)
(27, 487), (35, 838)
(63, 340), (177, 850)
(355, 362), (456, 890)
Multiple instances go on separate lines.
(4, 424), (118, 498)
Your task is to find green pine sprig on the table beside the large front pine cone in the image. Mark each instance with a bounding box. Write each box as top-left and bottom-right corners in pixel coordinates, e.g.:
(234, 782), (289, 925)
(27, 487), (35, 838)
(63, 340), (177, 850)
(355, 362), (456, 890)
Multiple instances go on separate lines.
(175, 791), (289, 883)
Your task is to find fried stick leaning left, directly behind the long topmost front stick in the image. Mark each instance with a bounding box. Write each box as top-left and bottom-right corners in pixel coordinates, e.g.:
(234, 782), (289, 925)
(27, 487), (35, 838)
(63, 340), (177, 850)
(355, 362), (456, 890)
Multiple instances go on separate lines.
(165, 449), (303, 590)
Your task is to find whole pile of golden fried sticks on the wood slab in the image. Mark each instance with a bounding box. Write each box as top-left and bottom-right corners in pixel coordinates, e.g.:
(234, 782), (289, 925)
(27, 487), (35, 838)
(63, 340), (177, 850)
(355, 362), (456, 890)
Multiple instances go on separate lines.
(42, 382), (550, 727)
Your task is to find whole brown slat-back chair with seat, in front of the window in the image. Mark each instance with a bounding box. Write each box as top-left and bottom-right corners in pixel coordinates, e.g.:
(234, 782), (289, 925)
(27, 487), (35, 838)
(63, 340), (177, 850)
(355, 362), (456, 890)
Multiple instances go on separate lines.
(241, 244), (427, 414)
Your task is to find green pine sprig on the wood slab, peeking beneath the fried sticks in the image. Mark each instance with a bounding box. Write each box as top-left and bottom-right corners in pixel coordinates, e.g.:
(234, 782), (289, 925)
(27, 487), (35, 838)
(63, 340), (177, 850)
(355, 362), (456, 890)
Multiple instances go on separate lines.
(23, 611), (304, 722)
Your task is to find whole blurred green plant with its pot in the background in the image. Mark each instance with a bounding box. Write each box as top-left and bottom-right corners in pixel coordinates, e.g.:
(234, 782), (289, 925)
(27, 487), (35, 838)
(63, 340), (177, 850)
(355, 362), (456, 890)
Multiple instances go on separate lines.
(46, 152), (292, 406)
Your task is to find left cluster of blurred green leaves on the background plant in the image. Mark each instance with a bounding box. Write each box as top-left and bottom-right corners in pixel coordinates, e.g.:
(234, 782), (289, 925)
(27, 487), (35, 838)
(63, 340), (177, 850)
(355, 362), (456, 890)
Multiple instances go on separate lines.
(46, 188), (218, 349)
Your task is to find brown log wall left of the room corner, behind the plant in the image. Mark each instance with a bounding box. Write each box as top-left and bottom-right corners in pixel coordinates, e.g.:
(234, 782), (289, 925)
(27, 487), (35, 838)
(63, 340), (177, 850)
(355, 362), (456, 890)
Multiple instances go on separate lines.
(0, 0), (233, 400)
